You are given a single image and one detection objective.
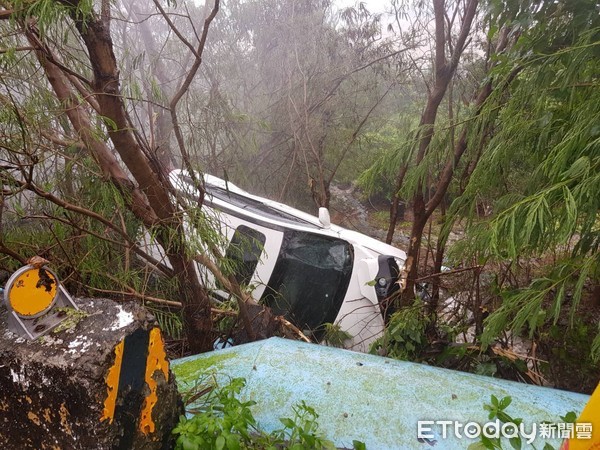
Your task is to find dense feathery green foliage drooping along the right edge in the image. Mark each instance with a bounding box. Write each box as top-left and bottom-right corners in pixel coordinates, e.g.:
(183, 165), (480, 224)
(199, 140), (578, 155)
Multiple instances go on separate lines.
(453, 2), (600, 360)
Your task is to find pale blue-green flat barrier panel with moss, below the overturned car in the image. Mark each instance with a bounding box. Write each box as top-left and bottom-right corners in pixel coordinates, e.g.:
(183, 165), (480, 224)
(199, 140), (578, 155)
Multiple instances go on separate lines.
(172, 338), (589, 450)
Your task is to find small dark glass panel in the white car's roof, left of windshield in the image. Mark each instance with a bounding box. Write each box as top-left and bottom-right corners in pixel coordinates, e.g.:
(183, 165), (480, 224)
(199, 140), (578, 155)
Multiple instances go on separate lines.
(225, 225), (266, 286)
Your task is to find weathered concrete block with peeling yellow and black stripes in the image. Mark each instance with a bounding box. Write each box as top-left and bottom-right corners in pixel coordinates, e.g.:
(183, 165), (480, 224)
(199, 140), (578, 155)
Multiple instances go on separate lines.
(0, 299), (183, 450)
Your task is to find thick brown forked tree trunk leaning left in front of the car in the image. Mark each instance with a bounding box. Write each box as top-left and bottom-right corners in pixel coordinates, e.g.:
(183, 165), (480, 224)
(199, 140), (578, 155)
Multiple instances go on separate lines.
(38, 6), (212, 352)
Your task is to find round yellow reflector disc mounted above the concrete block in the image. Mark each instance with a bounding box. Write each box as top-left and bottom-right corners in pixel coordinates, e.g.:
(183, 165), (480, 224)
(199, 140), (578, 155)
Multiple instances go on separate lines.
(7, 266), (57, 319)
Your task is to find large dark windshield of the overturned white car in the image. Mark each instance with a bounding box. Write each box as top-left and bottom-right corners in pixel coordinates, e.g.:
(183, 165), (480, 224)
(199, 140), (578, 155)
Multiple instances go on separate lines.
(261, 230), (353, 337)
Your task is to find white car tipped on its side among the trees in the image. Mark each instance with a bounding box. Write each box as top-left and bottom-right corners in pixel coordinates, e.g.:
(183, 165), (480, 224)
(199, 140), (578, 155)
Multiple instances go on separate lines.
(169, 170), (406, 351)
